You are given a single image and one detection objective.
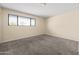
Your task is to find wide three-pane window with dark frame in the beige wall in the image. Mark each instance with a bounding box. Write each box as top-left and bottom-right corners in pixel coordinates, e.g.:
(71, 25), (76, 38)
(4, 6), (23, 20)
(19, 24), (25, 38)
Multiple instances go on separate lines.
(8, 14), (36, 26)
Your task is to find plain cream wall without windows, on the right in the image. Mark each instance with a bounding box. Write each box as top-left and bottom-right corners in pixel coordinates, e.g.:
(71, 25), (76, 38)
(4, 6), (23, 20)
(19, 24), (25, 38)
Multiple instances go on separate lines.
(47, 10), (79, 41)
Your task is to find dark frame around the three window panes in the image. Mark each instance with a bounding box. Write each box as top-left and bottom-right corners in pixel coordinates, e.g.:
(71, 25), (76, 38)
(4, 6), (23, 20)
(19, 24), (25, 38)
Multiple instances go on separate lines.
(8, 14), (36, 27)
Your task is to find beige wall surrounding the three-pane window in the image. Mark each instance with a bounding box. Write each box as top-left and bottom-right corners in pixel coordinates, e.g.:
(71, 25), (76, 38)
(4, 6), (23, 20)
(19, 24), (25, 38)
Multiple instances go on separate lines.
(2, 8), (45, 42)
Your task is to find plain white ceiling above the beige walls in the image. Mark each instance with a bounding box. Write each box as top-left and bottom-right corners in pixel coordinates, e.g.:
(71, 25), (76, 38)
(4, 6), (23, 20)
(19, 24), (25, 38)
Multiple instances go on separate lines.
(0, 3), (79, 17)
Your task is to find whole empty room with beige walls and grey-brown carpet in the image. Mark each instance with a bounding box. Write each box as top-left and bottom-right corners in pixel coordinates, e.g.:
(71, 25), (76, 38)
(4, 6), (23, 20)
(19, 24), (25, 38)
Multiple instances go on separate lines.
(0, 3), (79, 55)
